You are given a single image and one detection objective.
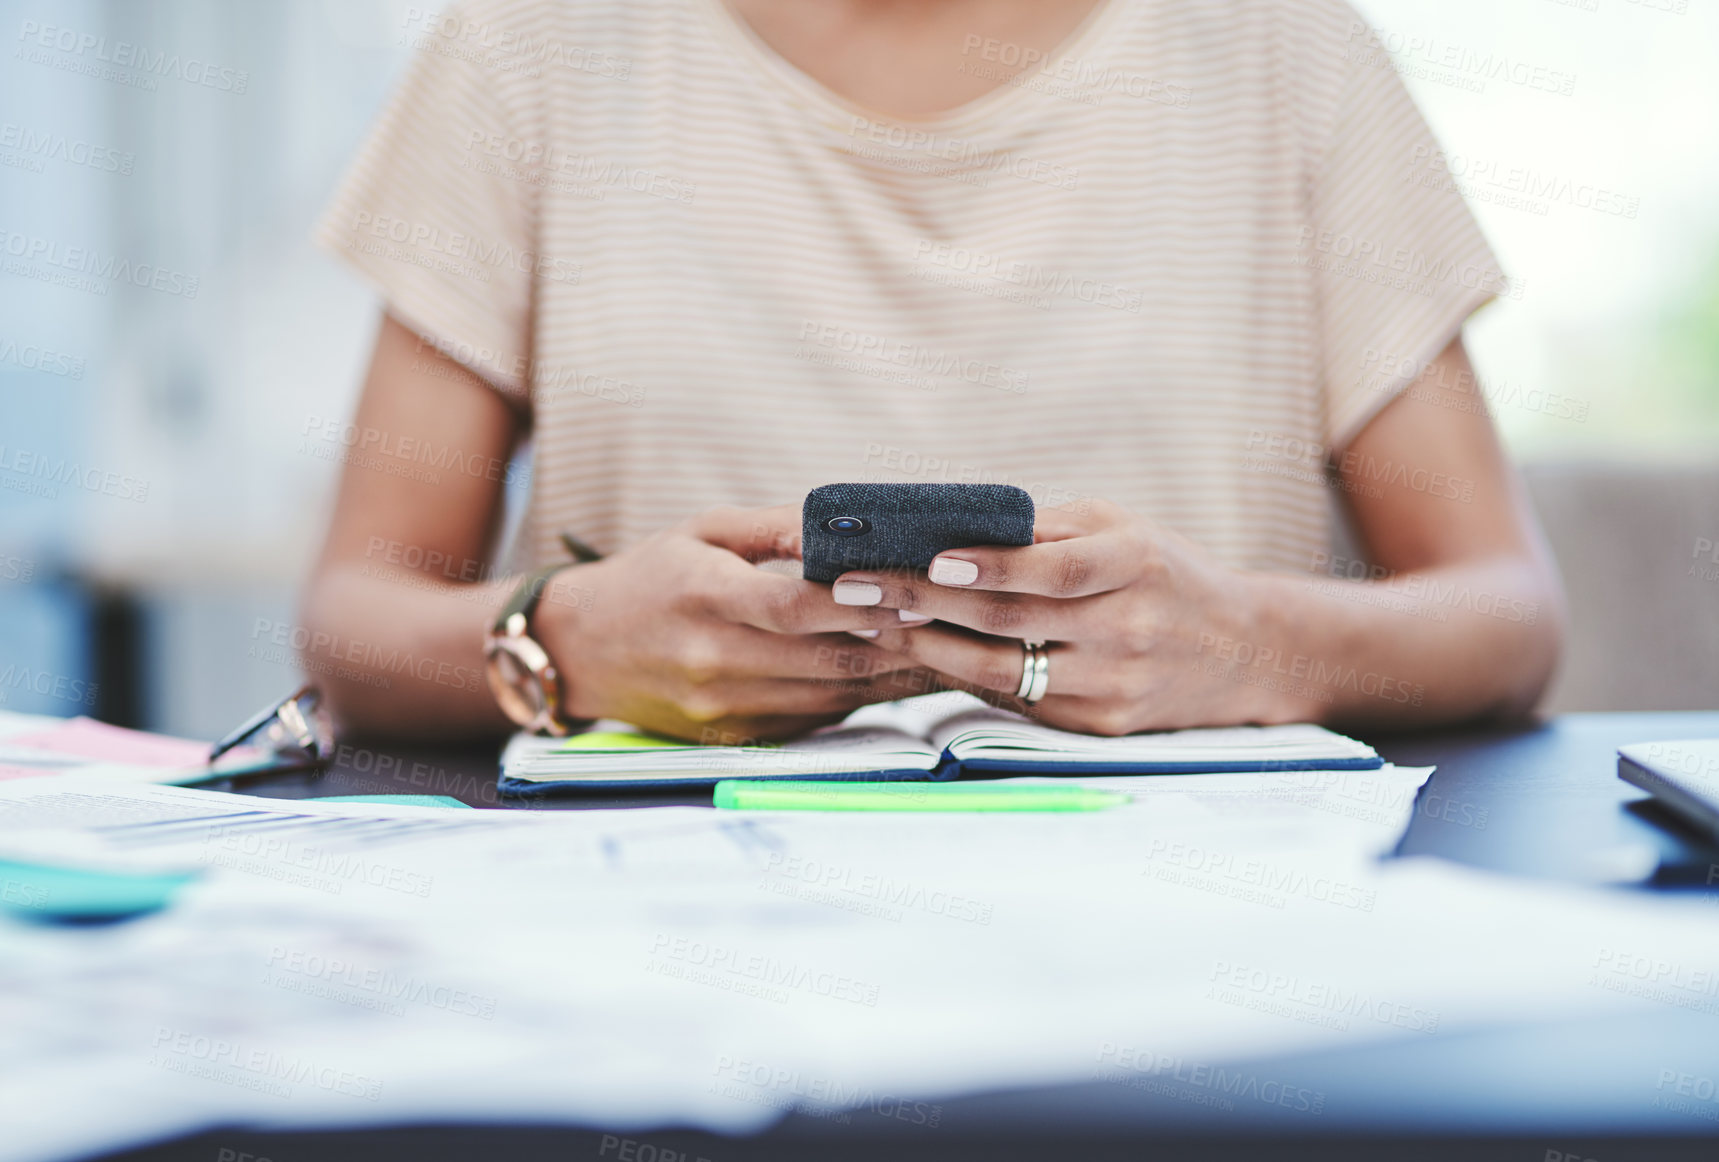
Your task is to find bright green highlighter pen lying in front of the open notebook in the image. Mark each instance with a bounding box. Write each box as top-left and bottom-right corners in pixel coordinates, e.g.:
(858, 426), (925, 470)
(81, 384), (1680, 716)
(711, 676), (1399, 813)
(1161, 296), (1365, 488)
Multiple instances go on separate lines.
(713, 779), (1129, 811)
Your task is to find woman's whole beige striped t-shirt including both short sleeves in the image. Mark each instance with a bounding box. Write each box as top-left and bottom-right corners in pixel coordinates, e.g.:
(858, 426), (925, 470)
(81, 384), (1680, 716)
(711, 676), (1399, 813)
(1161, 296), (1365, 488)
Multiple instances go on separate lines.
(320, 0), (1509, 571)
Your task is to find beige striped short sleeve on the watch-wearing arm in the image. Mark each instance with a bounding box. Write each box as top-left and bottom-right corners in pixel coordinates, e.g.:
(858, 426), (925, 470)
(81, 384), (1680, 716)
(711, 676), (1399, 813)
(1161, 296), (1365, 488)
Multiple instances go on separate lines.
(316, 5), (546, 409)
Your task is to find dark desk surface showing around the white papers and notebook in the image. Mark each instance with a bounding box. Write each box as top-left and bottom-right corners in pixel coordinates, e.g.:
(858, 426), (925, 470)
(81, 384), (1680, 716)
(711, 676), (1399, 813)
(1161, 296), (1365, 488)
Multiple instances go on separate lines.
(103, 713), (1719, 1162)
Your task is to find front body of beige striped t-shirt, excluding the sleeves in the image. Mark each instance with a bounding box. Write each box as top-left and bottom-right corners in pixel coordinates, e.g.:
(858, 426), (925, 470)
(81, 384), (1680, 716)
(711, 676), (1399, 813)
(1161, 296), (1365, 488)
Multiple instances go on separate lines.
(469, 0), (1354, 569)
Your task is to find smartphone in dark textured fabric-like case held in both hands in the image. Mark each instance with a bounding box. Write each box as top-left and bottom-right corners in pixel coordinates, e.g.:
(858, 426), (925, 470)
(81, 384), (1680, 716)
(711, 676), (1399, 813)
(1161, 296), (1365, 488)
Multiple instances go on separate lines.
(801, 485), (1033, 584)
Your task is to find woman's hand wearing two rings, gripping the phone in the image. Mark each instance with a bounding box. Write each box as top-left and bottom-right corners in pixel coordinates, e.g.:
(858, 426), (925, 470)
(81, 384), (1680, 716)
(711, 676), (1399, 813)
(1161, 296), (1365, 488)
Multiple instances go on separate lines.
(834, 502), (1317, 734)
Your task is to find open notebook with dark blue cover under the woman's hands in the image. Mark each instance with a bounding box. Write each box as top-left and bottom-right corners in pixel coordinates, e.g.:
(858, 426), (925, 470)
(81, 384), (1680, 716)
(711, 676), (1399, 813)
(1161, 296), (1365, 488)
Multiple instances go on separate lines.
(500, 693), (1384, 794)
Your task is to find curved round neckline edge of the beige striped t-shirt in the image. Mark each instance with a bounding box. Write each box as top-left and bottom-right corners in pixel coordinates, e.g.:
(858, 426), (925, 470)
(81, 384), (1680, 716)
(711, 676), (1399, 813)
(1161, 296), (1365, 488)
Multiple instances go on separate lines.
(693, 0), (1128, 131)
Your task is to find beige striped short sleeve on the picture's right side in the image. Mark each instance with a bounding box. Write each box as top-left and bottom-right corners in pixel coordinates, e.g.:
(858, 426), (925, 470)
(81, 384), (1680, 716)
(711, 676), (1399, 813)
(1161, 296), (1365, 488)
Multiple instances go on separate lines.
(1294, 19), (1520, 450)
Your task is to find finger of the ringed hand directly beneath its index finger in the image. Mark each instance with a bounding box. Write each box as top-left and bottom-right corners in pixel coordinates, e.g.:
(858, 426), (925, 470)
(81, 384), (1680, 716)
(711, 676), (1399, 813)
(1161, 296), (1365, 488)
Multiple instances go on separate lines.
(814, 572), (1110, 641)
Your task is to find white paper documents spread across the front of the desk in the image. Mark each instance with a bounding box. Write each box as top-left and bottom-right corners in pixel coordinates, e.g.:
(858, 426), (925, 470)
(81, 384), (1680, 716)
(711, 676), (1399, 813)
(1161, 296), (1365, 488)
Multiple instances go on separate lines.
(0, 767), (1719, 1162)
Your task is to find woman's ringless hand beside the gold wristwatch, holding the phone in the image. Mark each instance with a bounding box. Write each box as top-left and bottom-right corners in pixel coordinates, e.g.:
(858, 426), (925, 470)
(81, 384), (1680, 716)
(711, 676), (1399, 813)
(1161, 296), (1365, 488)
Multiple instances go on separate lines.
(535, 505), (940, 744)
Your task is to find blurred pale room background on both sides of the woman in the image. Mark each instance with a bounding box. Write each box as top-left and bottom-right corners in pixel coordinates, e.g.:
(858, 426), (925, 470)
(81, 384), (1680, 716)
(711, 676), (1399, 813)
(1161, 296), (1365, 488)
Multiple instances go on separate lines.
(0, 0), (1719, 737)
